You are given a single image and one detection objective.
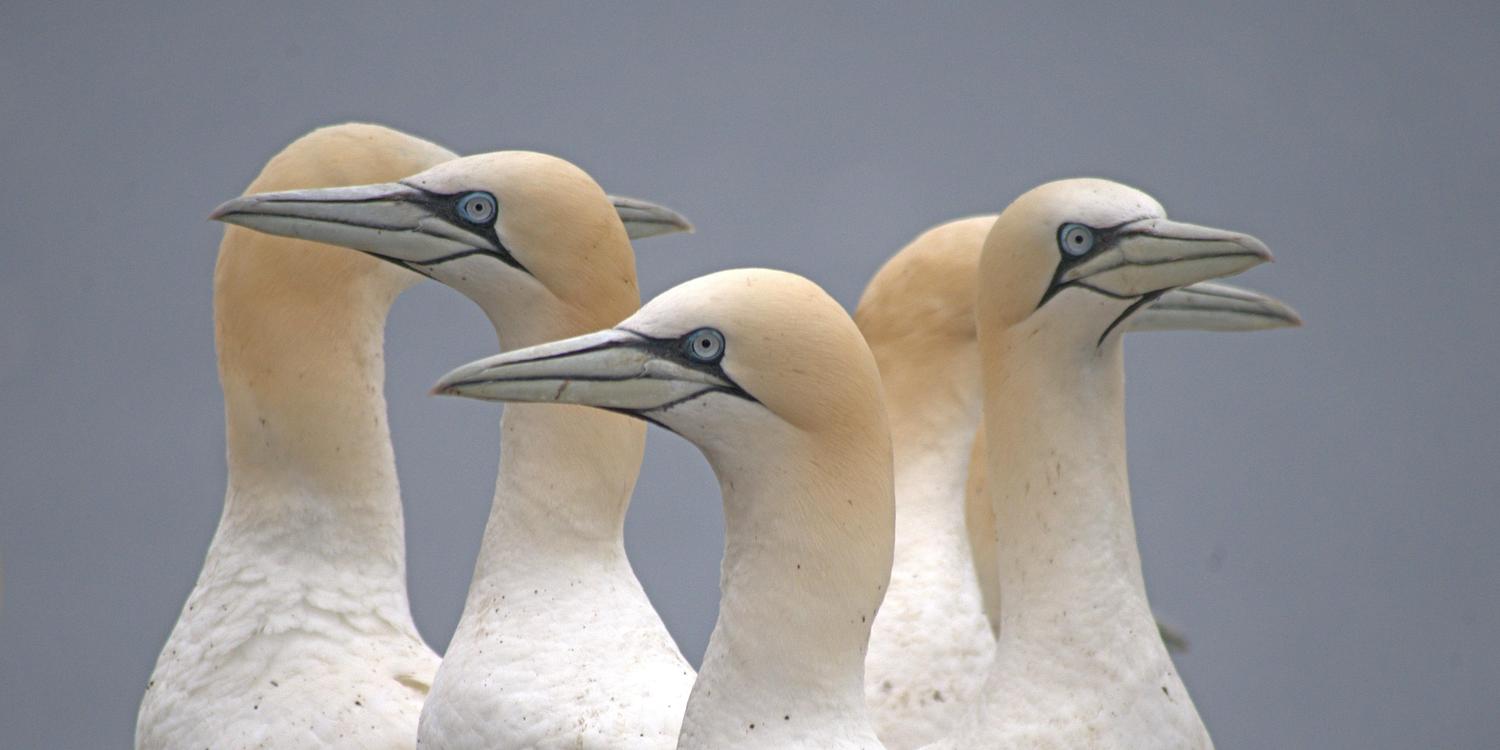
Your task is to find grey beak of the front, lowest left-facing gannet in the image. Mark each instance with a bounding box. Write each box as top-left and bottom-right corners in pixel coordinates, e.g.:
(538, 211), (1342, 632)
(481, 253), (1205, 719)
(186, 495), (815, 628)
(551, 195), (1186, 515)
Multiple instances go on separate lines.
(432, 329), (749, 414)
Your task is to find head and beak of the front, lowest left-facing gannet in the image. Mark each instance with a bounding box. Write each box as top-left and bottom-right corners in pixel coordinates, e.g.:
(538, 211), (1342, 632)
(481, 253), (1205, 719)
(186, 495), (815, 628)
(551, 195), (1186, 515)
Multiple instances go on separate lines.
(434, 269), (885, 458)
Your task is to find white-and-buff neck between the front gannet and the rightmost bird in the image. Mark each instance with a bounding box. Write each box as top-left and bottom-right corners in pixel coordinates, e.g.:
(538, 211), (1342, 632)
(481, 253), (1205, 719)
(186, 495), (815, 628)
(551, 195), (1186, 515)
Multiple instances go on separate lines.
(866, 338), (995, 749)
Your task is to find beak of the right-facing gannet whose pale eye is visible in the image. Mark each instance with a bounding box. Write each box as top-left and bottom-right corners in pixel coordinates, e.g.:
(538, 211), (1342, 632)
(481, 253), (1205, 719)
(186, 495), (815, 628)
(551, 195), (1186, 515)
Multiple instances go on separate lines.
(1056, 219), (1271, 299)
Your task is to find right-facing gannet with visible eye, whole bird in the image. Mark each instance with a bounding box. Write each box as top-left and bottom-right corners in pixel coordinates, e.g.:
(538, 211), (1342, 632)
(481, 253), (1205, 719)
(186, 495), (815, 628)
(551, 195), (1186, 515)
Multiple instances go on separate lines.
(944, 180), (1271, 747)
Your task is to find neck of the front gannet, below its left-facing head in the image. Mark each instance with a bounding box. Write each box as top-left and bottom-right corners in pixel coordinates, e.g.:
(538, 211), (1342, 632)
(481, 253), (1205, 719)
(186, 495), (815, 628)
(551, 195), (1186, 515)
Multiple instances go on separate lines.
(678, 441), (893, 749)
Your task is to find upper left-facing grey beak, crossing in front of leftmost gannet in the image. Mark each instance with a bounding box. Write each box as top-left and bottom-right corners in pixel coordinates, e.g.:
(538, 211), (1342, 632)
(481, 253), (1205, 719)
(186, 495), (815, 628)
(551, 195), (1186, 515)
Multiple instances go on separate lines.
(209, 183), (519, 267)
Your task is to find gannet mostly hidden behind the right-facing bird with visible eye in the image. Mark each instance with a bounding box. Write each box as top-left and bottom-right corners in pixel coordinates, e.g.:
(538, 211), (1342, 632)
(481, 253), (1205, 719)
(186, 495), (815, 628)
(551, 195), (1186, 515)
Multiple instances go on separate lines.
(854, 215), (1296, 750)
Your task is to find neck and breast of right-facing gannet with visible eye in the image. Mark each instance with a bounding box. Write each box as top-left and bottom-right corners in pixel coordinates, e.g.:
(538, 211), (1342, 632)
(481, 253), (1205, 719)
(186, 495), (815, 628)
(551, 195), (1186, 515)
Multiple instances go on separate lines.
(957, 323), (1211, 747)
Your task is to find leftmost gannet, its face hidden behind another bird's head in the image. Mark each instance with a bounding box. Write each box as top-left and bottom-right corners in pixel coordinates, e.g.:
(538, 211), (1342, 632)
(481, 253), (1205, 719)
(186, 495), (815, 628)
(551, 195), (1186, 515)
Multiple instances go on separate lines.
(135, 125), (453, 749)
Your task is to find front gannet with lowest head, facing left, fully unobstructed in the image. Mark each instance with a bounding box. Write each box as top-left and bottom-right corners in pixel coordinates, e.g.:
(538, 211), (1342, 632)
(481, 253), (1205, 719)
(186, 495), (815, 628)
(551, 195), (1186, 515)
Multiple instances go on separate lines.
(435, 270), (894, 750)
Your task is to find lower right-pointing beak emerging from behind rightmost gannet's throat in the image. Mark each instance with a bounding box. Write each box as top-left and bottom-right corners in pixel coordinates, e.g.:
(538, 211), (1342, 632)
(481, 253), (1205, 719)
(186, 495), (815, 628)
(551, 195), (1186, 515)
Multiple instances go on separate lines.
(1125, 282), (1302, 332)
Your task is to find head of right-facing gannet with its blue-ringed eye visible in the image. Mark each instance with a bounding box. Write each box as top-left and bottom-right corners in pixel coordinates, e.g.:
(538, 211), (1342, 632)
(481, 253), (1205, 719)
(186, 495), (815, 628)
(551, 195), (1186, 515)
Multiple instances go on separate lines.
(978, 179), (1295, 345)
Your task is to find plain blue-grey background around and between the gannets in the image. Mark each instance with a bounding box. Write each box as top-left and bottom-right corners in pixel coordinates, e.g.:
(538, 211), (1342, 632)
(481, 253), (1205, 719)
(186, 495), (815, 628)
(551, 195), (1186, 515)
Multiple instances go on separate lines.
(0, 0), (1500, 749)
